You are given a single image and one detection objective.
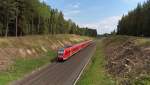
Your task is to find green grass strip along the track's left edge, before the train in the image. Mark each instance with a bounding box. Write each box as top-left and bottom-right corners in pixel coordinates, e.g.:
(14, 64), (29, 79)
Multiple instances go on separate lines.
(0, 51), (56, 85)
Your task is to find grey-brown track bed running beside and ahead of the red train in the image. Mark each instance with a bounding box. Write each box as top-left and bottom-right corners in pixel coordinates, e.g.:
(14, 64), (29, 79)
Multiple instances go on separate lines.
(13, 43), (95, 85)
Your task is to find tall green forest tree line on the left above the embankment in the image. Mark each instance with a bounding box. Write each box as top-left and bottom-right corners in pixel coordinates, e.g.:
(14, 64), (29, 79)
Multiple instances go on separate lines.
(0, 0), (97, 37)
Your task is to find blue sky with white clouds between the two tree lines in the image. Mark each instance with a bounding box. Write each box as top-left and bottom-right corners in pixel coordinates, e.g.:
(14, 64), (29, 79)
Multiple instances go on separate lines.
(44, 0), (146, 34)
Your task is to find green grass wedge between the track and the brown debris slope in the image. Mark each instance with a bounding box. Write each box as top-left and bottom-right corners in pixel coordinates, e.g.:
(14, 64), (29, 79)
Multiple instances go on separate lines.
(77, 40), (115, 85)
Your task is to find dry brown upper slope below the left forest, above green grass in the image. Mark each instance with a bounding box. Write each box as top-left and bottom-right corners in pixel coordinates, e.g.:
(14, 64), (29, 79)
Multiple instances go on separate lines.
(0, 35), (89, 71)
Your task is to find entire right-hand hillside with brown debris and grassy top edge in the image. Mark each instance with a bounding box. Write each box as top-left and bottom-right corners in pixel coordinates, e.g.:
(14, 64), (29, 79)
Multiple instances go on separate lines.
(103, 36), (150, 85)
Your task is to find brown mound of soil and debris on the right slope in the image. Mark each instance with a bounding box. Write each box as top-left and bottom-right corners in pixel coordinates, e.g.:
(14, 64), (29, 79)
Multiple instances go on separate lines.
(106, 39), (150, 85)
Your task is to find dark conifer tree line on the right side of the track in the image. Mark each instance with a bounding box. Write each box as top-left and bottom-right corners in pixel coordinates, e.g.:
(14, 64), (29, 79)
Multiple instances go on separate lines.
(117, 0), (150, 37)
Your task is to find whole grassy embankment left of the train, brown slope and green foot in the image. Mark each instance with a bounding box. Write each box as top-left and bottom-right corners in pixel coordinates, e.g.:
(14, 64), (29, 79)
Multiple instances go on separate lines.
(0, 34), (88, 85)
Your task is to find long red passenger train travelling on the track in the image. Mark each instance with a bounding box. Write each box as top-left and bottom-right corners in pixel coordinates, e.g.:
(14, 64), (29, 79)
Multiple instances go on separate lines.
(57, 40), (92, 61)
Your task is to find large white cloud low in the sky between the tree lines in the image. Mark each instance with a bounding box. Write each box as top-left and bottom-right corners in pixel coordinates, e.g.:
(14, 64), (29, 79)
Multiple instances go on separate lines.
(81, 16), (121, 34)
